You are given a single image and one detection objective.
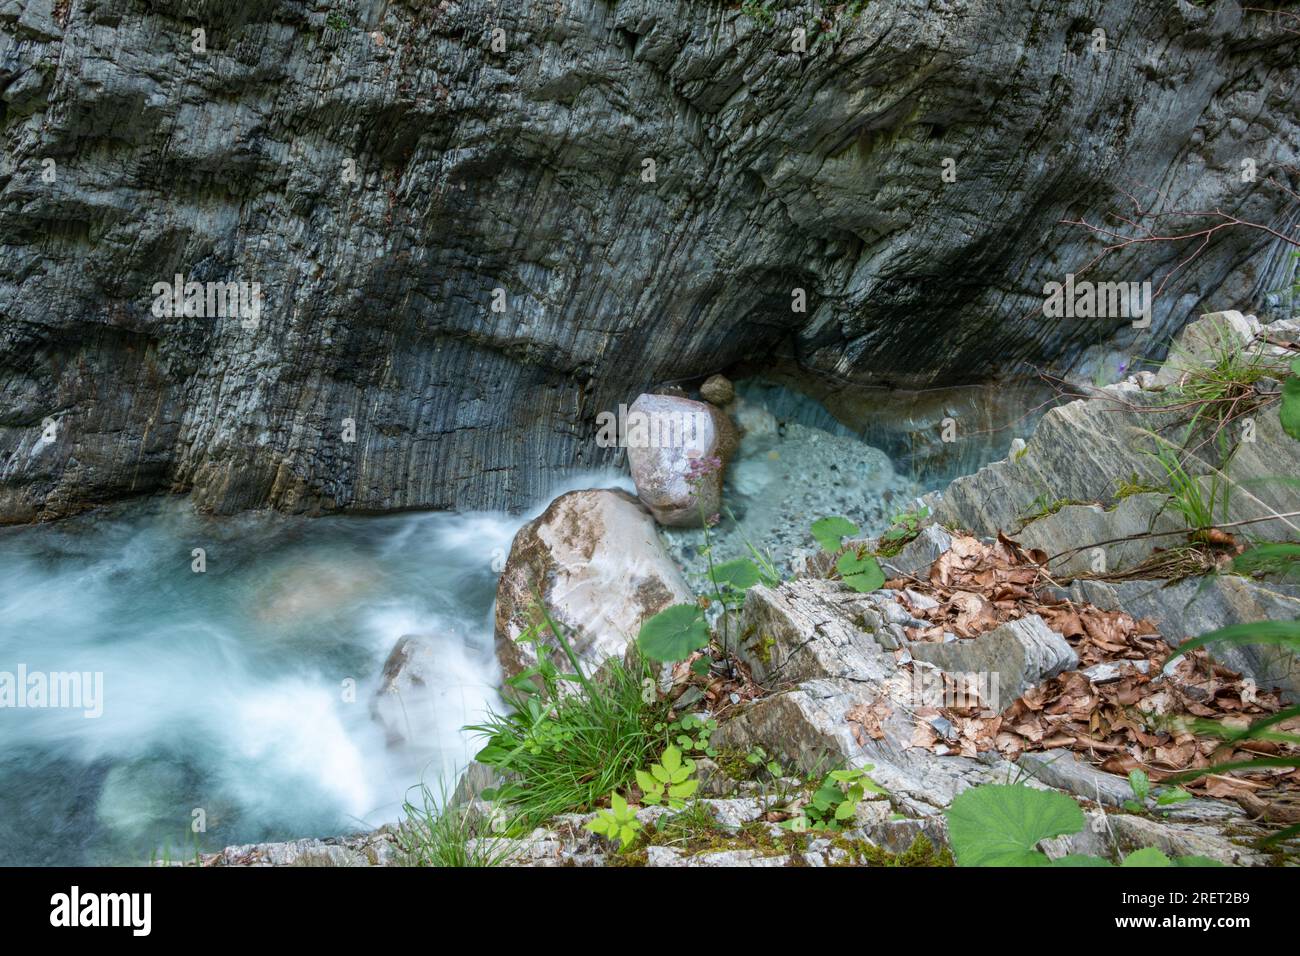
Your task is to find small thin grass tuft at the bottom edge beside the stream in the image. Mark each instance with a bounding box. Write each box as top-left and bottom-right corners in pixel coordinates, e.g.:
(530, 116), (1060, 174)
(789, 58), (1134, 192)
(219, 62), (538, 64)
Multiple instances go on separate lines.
(395, 783), (510, 866)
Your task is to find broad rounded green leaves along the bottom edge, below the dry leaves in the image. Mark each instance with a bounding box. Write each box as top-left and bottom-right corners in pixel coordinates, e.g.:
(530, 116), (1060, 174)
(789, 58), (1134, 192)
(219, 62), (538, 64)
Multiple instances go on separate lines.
(946, 782), (1219, 866)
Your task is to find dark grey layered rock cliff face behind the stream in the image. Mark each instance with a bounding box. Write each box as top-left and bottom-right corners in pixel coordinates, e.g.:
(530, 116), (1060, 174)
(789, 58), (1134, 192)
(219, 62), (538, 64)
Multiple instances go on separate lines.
(0, 0), (1300, 520)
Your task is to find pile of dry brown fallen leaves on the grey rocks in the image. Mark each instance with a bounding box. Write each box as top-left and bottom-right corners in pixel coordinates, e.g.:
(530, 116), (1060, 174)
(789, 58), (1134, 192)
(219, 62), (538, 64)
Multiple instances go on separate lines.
(889, 535), (1300, 822)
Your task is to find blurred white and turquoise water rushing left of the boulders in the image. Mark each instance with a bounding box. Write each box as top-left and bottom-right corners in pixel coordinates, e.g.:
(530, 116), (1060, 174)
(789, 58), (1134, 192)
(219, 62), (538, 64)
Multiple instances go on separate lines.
(0, 473), (629, 865)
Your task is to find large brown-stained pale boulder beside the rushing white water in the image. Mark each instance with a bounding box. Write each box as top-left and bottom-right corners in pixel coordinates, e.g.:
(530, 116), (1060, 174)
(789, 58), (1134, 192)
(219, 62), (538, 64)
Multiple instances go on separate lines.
(497, 489), (694, 676)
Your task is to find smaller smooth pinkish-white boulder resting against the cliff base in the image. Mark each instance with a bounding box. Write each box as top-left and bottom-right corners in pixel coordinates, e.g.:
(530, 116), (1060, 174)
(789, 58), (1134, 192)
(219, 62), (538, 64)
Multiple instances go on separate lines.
(623, 395), (737, 528)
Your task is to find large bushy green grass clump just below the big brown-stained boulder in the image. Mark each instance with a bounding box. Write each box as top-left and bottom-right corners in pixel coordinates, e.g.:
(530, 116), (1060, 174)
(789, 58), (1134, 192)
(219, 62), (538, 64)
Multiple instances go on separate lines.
(467, 611), (666, 827)
